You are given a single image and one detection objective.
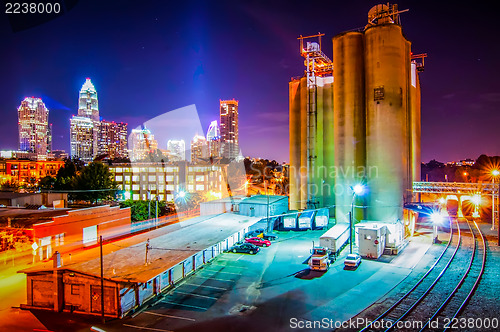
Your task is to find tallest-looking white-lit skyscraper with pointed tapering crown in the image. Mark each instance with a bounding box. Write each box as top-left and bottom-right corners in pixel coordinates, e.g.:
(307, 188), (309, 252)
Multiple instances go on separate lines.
(70, 78), (99, 161)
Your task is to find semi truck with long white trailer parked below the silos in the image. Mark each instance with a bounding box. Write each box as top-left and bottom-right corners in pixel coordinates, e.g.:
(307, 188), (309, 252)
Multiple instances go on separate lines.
(308, 223), (349, 271)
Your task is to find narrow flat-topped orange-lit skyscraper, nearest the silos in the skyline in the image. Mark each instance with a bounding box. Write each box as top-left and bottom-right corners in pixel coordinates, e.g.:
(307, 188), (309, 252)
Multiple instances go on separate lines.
(220, 99), (240, 159)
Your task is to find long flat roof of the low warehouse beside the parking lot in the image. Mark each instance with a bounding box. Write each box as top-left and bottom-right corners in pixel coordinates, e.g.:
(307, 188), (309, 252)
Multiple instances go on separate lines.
(19, 213), (260, 283)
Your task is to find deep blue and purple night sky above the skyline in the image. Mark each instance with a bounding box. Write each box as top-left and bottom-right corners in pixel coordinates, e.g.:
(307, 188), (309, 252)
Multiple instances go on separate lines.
(0, 0), (500, 162)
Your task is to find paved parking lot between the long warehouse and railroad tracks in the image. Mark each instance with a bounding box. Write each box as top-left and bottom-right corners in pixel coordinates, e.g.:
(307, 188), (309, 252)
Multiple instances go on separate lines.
(102, 231), (425, 331)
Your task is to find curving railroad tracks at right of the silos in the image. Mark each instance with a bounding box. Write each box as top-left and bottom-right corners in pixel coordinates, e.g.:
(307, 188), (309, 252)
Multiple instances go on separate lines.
(360, 221), (486, 332)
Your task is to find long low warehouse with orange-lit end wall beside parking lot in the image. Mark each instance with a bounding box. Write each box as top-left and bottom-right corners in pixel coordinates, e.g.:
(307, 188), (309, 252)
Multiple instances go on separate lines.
(20, 213), (259, 317)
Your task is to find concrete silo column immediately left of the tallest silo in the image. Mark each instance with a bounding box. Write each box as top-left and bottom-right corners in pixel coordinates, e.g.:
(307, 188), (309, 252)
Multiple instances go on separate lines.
(332, 32), (366, 222)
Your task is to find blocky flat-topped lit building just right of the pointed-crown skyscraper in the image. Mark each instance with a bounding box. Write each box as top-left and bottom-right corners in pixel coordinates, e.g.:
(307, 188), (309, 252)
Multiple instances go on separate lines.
(97, 120), (128, 159)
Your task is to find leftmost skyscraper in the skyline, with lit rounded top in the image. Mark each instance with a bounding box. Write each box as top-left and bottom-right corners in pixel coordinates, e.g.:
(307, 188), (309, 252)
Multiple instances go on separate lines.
(17, 97), (52, 159)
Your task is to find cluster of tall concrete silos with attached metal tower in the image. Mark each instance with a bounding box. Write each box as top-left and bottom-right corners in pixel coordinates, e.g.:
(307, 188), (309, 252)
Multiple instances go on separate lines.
(289, 4), (425, 226)
